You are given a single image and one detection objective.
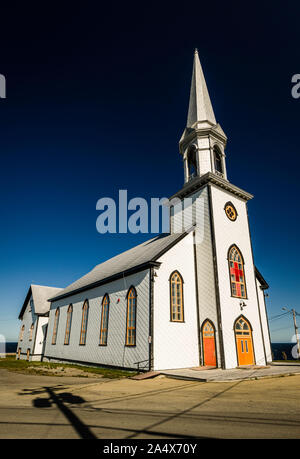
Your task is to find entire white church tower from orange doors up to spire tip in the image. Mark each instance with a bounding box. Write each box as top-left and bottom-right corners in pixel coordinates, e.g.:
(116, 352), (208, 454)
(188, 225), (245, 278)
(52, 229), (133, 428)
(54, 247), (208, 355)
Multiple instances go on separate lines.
(169, 50), (272, 368)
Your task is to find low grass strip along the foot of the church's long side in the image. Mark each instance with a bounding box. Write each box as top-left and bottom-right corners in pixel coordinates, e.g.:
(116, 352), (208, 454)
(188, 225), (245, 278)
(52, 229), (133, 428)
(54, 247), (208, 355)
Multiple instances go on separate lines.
(0, 356), (137, 379)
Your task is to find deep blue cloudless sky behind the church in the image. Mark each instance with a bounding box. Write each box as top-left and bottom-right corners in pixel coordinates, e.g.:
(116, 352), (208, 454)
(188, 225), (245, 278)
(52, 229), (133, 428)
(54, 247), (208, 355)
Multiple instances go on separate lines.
(0, 1), (300, 341)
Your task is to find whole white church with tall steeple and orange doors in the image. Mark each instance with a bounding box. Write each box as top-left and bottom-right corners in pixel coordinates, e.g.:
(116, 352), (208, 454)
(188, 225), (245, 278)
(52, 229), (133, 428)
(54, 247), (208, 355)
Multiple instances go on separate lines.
(18, 51), (272, 370)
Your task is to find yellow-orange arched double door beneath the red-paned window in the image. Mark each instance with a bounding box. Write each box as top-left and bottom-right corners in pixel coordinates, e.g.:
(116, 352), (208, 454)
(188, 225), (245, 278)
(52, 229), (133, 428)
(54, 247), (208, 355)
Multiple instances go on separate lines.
(234, 316), (255, 366)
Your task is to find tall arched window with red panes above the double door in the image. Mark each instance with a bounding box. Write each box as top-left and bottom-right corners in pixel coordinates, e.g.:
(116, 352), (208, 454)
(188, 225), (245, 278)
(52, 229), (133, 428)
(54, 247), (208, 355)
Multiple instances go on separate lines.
(228, 245), (247, 298)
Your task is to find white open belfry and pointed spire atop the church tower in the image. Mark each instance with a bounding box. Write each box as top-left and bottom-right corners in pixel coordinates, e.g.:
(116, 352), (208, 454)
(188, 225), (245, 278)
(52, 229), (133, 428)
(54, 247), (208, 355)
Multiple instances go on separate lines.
(179, 49), (227, 183)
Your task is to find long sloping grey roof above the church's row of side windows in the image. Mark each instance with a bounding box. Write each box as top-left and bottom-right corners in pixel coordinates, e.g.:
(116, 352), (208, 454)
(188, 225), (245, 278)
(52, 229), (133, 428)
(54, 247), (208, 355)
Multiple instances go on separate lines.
(49, 231), (189, 301)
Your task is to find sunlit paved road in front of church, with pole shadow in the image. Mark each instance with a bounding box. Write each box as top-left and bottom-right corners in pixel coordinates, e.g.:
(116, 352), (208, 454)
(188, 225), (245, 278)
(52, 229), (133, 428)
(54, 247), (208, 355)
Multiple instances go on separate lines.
(0, 370), (300, 439)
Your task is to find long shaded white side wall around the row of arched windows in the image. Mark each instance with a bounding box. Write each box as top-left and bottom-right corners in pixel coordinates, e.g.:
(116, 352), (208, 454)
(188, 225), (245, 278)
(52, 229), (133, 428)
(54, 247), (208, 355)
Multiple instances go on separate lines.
(44, 269), (150, 369)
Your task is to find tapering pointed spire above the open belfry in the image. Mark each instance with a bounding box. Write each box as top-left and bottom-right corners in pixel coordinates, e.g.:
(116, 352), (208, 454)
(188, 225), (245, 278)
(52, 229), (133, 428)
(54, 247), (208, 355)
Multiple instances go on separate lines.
(187, 48), (217, 127)
